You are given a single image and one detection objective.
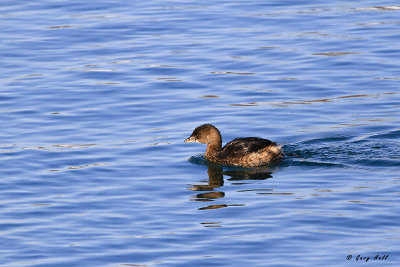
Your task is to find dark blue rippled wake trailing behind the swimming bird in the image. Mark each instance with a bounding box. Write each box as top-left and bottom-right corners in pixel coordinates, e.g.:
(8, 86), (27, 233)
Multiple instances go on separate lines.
(283, 129), (400, 167)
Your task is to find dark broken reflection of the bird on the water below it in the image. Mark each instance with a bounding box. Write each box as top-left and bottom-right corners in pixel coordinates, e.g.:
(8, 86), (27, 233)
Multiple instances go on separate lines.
(188, 157), (272, 210)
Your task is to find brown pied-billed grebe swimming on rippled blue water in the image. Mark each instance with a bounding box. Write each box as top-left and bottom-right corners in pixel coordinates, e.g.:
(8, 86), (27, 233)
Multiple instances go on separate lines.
(185, 124), (283, 167)
